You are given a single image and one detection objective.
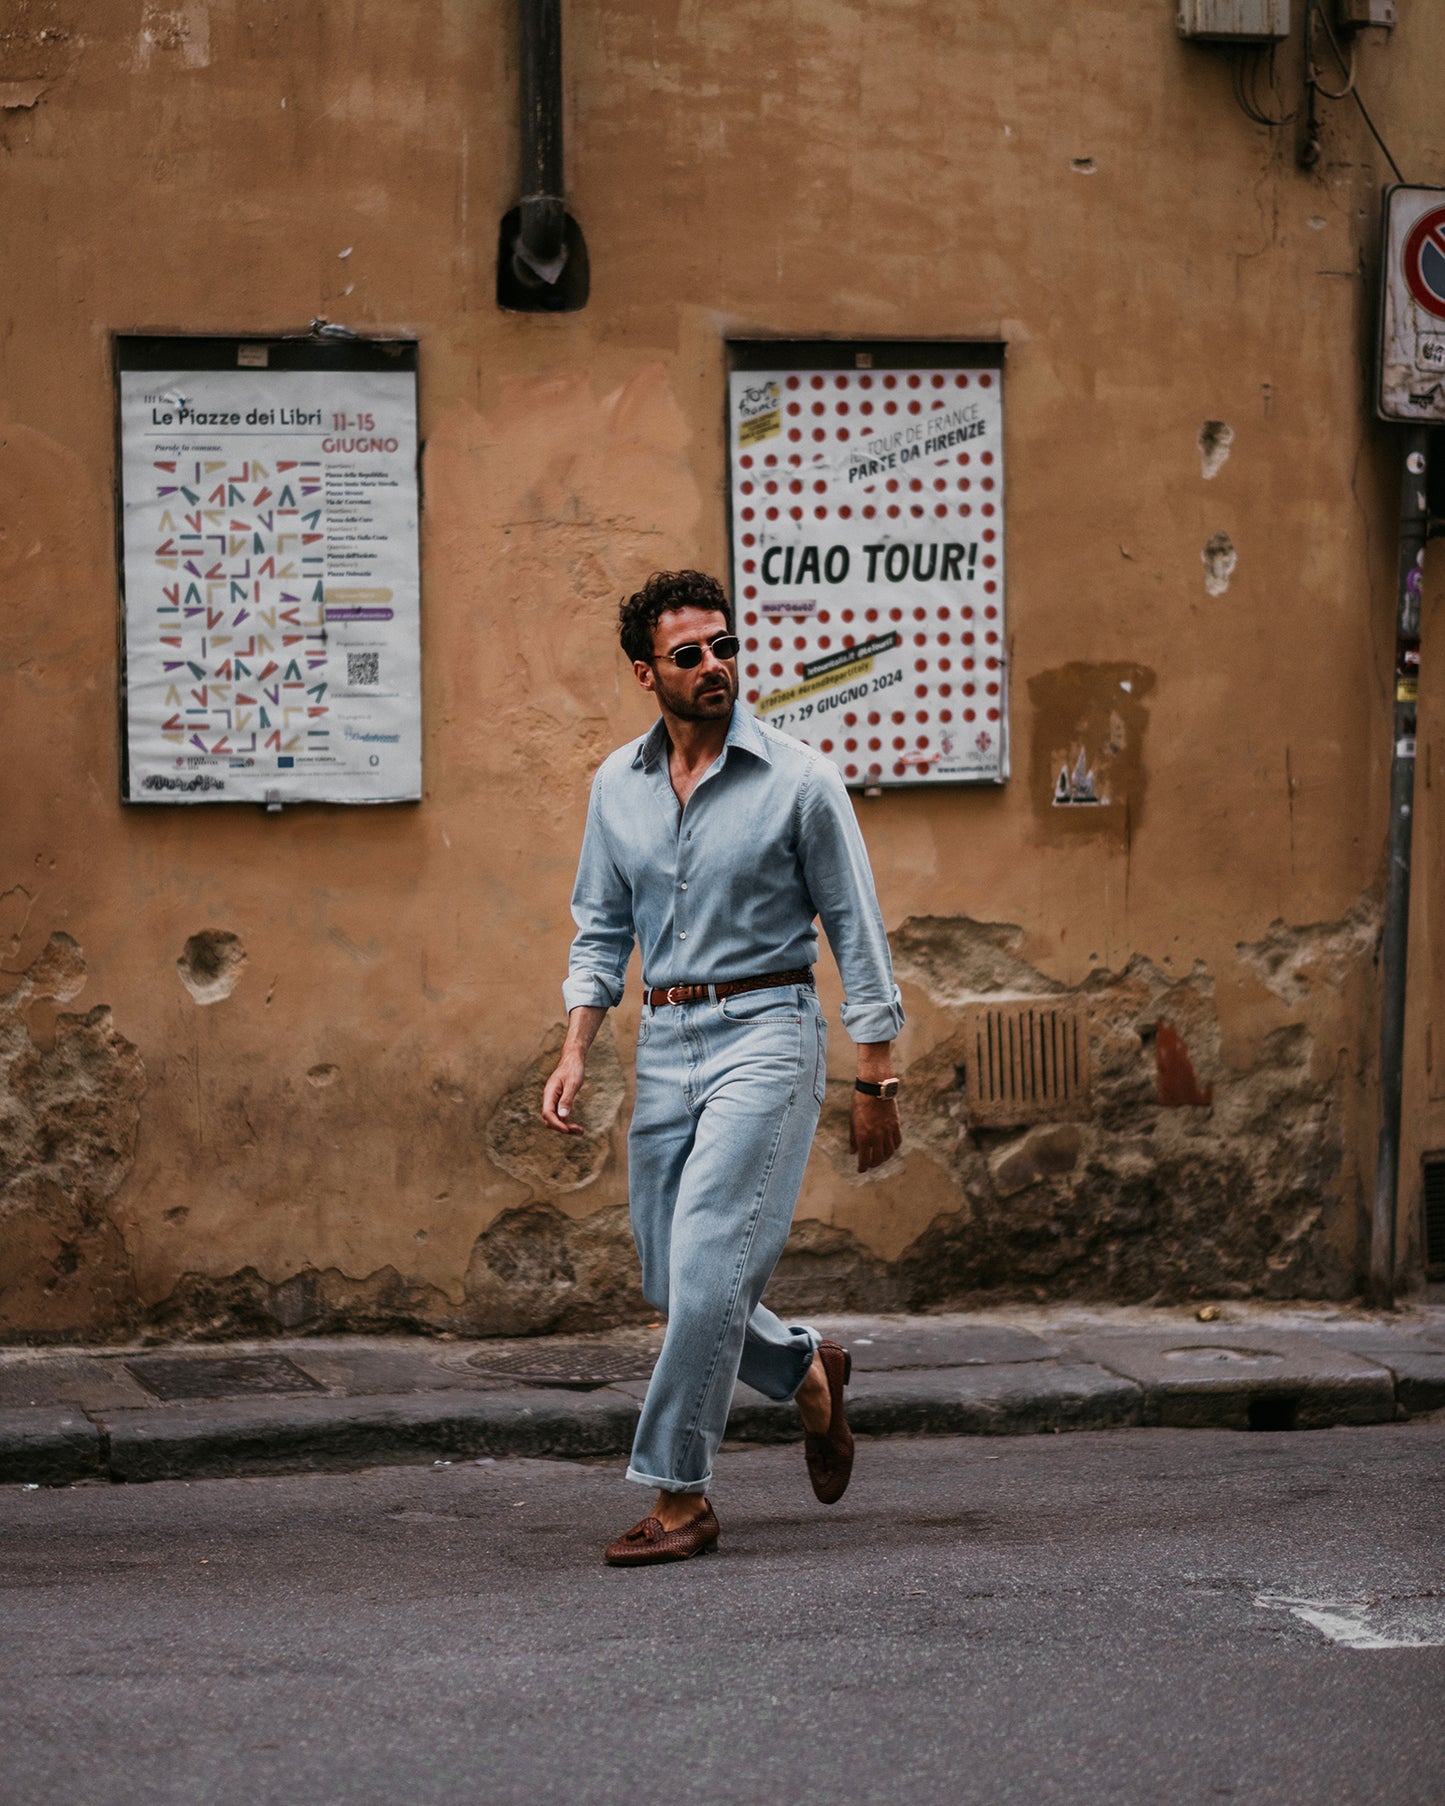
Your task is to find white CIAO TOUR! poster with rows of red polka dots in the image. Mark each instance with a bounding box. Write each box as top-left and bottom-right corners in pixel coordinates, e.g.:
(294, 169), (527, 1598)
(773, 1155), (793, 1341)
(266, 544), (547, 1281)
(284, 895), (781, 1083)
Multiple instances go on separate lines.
(728, 343), (1008, 789)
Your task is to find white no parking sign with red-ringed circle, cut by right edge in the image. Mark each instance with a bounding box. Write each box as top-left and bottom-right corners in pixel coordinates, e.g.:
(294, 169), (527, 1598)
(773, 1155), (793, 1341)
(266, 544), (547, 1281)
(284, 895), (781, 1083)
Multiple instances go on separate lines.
(1376, 186), (1445, 423)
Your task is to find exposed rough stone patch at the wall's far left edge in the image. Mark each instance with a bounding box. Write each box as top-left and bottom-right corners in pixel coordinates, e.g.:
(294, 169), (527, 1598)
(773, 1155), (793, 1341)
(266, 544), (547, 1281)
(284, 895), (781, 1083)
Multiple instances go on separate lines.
(0, 934), (145, 1342)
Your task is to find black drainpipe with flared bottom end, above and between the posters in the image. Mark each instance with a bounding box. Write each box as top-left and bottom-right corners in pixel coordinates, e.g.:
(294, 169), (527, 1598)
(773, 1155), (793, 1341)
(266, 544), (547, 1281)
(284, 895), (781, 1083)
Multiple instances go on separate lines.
(497, 0), (587, 314)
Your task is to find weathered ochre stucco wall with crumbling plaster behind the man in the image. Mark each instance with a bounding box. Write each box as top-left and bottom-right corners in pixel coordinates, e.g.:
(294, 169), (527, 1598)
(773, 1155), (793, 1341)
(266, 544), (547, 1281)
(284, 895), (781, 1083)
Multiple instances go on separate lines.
(0, 0), (1445, 1338)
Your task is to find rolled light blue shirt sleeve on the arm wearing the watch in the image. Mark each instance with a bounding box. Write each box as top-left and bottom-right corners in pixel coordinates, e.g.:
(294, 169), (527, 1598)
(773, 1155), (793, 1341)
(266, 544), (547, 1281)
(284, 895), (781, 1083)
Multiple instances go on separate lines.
(798, 759), (903, 1042)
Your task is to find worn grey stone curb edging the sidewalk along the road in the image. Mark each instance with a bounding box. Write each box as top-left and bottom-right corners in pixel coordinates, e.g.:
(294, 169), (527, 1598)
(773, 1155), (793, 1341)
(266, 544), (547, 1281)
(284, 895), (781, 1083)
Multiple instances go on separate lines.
(0, 1333), (1445, 1486)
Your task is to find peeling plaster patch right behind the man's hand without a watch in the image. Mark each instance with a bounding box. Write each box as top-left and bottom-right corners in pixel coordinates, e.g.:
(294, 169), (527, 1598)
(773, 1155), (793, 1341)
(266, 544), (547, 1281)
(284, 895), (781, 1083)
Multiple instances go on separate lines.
(486, 1022), (627, 1196)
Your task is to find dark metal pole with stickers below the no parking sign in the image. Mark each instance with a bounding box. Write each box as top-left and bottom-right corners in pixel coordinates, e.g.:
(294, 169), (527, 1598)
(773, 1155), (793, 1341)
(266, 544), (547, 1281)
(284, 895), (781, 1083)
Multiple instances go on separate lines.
(1369, 426), (1429, 1309)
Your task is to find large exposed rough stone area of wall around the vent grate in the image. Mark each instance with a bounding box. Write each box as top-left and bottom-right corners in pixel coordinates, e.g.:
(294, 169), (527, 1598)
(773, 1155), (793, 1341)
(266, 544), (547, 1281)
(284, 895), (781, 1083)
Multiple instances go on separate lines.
(896, 921), (1369, 1308)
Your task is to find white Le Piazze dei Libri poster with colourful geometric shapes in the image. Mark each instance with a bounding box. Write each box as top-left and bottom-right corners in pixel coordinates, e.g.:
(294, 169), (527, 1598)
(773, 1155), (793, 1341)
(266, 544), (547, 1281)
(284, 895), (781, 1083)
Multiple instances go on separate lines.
(117, 340), (421, 807)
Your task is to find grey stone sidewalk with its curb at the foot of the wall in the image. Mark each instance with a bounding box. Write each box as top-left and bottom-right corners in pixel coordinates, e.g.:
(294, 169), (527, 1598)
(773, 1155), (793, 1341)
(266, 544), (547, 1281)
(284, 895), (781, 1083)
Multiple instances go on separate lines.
(0, 1300), (1445, 1486)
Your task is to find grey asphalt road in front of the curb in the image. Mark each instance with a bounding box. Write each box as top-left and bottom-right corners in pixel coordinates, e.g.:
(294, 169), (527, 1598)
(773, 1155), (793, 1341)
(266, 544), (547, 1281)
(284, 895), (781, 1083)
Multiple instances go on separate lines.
(0, 1423), (1445, 1806)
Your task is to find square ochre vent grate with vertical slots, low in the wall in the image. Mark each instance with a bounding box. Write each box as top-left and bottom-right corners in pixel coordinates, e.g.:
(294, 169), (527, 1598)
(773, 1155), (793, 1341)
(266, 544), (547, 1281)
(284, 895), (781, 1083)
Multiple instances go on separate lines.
(963, 1002), (1089, 1129)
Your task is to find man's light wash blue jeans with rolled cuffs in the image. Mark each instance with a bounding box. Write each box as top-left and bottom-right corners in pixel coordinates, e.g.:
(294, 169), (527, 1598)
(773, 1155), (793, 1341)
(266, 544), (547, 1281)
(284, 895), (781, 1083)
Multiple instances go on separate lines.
(627, 984), (827, 1492)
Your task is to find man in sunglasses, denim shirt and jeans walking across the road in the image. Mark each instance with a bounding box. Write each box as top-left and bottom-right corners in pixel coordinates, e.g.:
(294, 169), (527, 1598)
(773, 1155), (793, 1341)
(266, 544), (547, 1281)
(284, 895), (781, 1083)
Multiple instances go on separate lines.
(542, 571), (903, 1566)
